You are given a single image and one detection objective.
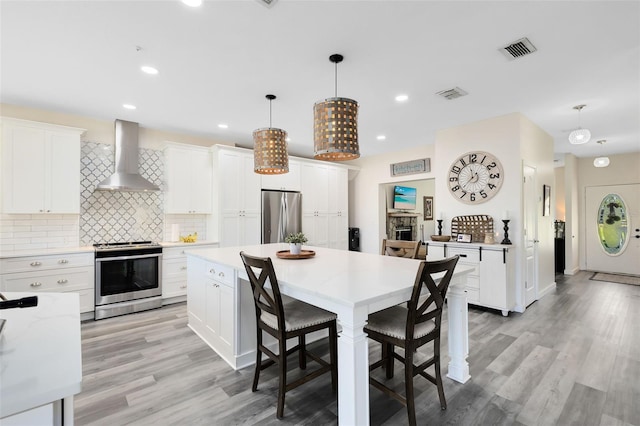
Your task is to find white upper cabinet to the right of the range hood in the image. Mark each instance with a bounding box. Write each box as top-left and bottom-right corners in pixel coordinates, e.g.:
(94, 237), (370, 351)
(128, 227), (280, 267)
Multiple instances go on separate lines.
(164, 143), (212, 214)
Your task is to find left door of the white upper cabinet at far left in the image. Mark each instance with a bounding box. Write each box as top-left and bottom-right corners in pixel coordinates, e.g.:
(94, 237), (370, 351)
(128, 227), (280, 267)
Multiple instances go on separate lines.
(2, 124), (47, 213)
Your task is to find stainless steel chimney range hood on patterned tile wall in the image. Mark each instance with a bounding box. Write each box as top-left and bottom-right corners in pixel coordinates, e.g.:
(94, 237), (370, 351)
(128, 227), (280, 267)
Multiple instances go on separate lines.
(96, 120), (160, 192)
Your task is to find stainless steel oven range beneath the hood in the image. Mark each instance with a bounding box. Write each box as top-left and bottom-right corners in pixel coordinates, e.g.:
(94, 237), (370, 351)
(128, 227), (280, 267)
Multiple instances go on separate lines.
(95, 241), (162, 320)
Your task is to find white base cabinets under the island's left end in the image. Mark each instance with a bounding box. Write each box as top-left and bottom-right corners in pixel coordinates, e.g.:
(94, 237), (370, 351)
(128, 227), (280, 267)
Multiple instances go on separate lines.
(187, 256), (256, 369)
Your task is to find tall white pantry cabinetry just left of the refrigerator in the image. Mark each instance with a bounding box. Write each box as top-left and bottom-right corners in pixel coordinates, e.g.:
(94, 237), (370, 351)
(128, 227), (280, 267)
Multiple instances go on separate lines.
(215, 147), (261, 247)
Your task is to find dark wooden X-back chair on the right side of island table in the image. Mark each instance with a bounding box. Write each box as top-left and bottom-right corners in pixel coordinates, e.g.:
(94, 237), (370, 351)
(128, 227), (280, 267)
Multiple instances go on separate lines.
(364, 256), (458, 425)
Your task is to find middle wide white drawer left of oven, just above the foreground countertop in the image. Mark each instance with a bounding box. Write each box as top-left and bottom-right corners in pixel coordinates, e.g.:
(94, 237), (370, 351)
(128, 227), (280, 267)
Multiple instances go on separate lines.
(2, 267), (94, 292)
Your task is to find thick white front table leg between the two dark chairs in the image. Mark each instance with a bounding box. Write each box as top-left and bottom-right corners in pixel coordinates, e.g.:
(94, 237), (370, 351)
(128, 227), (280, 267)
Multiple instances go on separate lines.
(338, 310), (369, 426)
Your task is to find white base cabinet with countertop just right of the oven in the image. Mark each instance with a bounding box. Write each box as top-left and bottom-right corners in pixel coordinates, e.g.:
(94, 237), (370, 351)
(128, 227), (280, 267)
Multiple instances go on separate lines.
(162, 244), (218, 304)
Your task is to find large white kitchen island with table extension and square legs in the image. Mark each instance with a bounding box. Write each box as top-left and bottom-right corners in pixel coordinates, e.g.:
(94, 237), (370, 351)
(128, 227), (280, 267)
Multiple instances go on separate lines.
(186, 244), (472, 425)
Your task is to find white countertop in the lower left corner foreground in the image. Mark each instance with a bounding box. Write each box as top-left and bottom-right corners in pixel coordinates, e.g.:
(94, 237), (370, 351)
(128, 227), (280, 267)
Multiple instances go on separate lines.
(0, 292), (82, 418)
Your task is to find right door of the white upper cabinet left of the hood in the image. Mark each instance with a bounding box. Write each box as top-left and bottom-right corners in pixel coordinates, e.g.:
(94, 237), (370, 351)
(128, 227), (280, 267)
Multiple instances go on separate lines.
(45, 132), (80, 214)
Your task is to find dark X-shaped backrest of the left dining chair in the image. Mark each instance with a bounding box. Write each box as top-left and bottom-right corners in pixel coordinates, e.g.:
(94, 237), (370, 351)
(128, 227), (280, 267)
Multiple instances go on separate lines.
(240, 252), (284, 330)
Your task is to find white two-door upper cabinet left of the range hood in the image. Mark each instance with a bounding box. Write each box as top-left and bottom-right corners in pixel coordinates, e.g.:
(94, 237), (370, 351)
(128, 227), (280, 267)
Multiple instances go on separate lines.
(0, 118), (85, 214)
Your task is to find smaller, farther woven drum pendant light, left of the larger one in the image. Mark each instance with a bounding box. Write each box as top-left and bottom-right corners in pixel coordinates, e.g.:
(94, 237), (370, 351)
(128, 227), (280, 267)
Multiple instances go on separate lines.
(253, 95), (289, 175)
